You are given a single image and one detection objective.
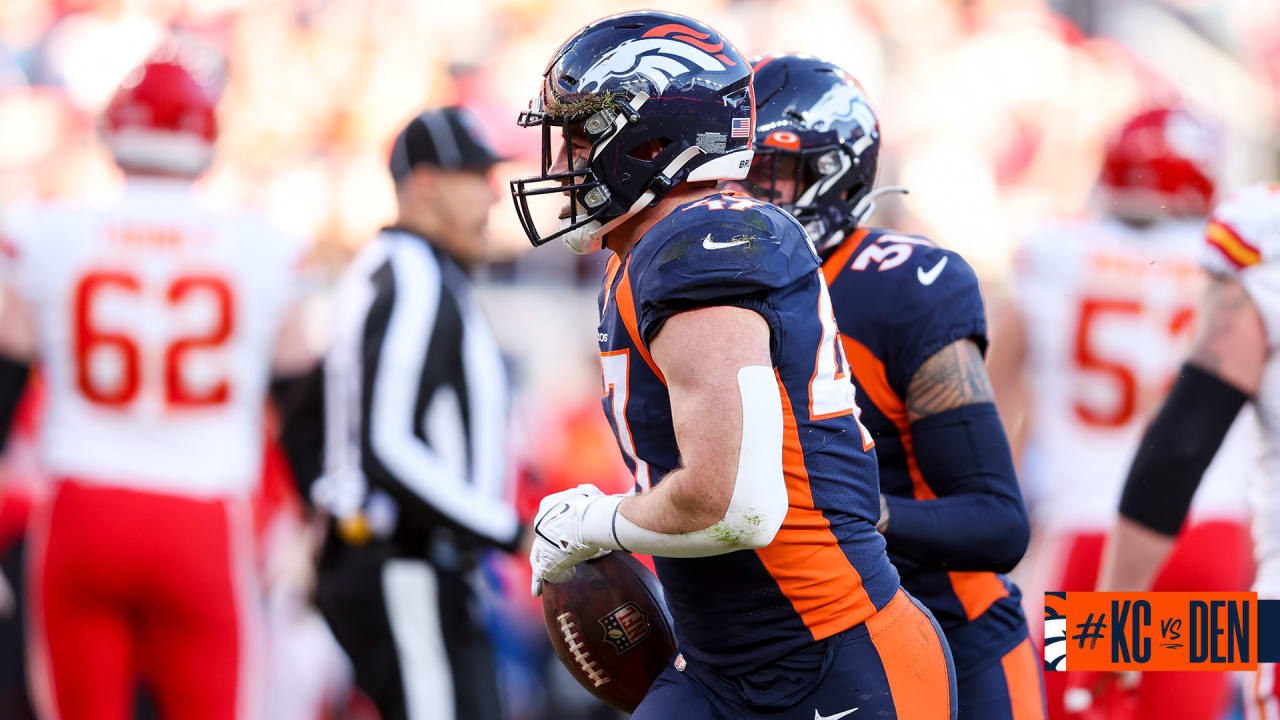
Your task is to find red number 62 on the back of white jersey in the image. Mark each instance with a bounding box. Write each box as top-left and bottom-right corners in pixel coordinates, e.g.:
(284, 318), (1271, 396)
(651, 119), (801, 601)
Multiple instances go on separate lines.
(72, 272), (236, 409)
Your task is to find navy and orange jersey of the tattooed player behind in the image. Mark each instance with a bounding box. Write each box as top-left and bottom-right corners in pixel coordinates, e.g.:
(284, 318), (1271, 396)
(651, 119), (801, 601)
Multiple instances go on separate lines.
(823, 228), (1027, 674)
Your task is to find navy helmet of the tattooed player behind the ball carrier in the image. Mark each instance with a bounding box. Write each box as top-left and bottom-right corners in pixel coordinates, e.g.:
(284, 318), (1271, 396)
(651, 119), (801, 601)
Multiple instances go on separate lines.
(745, 53), (879, 251)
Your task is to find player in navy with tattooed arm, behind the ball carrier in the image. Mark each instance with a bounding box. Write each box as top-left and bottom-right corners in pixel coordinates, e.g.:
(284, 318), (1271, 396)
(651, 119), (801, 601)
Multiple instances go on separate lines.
(728, 54), (1044, 720)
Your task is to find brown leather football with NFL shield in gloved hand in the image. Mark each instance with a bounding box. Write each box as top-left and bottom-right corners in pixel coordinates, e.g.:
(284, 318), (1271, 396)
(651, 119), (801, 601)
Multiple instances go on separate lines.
(543, 551), (676, 712)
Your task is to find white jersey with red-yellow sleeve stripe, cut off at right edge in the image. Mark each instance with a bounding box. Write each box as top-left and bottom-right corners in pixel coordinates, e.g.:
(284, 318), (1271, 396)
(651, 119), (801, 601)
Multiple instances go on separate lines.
(1202, 184), (1280, 598)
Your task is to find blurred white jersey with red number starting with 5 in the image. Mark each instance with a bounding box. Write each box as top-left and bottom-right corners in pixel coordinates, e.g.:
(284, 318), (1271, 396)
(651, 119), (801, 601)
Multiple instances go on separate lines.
(1016, 215), (1258, 532)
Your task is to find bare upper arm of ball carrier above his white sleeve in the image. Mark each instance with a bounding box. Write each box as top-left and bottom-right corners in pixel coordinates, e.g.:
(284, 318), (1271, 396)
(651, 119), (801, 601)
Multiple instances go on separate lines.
(649, 306), (772, 486)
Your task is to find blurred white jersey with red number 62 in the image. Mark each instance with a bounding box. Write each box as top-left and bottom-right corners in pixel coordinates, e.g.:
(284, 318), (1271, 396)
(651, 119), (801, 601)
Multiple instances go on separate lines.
(0, 179), (305, 497)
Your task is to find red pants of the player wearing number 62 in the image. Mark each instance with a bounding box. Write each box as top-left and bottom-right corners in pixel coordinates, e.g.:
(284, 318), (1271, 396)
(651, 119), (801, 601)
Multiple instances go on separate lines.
(29, 480), (262, 720)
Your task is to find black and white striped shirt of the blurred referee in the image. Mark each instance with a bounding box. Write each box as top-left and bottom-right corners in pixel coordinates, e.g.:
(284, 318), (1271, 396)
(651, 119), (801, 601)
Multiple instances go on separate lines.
(312, 228), (520, 547)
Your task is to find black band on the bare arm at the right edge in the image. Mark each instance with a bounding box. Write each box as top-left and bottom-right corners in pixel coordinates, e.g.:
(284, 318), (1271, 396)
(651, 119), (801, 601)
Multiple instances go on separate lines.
(1120, 364), (1249, 536)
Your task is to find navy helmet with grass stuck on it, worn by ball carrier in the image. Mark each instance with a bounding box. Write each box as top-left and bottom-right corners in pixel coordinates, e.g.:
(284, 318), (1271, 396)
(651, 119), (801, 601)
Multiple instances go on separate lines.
(511, 10), (754, 252)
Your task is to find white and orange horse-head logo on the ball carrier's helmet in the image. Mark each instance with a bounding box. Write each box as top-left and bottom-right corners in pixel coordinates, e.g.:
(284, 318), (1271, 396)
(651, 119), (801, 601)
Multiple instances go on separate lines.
(579, 24), (736, 95)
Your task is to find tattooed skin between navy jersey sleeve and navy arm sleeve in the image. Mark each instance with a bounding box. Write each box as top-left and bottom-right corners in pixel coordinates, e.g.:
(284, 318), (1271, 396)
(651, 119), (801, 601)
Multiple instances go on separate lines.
(906, 340), (995, 423)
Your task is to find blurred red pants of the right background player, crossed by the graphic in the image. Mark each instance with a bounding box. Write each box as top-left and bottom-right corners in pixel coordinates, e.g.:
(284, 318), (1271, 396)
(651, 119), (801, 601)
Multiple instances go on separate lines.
(1041, 520), (1253, 720)
